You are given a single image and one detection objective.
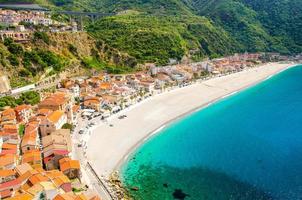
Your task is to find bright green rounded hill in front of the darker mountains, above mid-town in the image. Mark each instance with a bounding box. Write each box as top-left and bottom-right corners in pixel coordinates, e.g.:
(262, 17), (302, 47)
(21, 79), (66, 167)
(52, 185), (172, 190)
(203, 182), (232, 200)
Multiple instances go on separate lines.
(87, 13), (238, 64)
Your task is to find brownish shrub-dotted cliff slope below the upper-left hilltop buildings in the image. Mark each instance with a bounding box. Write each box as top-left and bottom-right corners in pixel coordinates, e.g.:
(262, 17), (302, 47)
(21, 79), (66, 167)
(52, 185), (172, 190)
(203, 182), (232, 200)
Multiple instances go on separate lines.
(0, 32), (137, 87)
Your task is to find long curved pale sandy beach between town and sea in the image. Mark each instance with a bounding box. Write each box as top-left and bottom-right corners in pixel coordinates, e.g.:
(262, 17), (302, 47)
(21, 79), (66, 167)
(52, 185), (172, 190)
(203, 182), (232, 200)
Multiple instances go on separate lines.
(87, 63), (293, 176)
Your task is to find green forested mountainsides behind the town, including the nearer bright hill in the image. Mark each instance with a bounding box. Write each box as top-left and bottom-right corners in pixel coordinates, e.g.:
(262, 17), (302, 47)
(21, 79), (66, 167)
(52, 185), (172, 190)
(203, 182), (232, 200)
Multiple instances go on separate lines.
(0, 0), (302, 64)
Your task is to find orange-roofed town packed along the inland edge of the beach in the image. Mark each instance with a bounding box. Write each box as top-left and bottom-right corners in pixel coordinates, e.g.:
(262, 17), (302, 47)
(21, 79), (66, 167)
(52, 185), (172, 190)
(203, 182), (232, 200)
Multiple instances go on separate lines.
(0, 48), (298, 199)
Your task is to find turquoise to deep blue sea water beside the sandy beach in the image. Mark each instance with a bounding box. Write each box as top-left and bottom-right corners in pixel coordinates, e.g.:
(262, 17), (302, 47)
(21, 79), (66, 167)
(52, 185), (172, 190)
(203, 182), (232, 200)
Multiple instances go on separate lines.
(122, 66), (302, 200)
